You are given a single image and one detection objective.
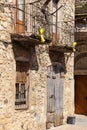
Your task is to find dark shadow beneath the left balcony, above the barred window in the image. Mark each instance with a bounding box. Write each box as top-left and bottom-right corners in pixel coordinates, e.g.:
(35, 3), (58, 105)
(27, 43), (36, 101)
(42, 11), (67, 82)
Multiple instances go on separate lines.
(13, 43), (39, 71)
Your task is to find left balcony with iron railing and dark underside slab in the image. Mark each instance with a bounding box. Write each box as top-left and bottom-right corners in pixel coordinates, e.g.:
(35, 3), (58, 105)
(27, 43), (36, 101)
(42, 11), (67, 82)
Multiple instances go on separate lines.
(11, 3), (52, 47)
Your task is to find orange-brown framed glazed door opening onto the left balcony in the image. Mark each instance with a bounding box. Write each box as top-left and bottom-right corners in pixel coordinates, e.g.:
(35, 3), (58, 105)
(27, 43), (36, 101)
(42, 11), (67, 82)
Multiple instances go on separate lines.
(16, 0), (25, 33)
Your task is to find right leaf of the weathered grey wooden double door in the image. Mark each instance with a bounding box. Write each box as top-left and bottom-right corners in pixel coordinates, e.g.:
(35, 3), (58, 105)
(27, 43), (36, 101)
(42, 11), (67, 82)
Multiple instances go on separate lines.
(54, 70), (63, 126)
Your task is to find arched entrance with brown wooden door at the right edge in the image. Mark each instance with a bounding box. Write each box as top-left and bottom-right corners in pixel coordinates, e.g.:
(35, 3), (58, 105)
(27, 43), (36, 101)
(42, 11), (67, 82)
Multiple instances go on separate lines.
(74, 51), (87, 115)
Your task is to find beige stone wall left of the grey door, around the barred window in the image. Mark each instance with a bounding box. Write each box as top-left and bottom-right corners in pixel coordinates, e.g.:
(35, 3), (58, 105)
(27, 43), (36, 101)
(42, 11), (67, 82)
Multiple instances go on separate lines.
(0, 1), (49, 130)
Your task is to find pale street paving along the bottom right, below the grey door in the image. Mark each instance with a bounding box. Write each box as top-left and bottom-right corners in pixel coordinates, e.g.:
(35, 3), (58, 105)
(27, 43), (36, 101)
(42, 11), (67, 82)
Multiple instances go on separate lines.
(48, 125), (87, 130)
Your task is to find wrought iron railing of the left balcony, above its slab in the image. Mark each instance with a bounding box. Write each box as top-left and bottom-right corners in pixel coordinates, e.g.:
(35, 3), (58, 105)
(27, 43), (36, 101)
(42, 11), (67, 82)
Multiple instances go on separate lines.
(12, 3), (53, 45)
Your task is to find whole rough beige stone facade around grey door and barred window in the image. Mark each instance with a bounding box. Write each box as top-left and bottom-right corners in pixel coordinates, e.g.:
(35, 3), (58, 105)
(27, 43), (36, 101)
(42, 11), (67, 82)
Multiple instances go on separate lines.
(0, 0), (75, 130)
